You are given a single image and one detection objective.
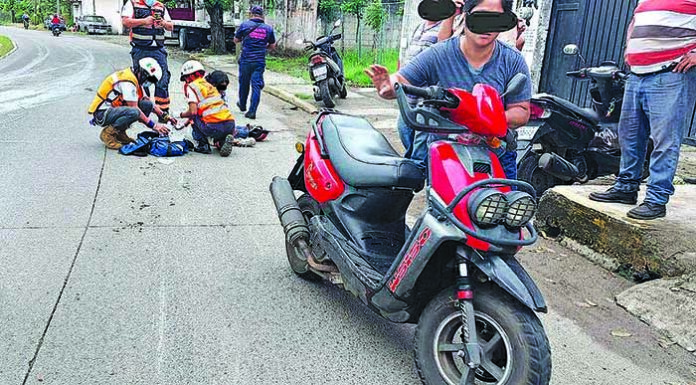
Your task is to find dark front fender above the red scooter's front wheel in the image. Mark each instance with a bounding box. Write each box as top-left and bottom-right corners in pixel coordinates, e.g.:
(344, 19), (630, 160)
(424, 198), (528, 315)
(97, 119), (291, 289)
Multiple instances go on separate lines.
(464, 246), (547, 313)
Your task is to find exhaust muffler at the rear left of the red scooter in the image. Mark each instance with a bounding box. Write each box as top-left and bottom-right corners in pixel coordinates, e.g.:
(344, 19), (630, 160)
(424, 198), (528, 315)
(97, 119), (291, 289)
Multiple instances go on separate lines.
(270, 176), (309, 245)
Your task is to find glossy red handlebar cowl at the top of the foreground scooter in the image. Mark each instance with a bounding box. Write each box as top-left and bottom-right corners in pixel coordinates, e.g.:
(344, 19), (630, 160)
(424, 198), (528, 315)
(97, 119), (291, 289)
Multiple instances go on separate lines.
(442, 84), (507, 138)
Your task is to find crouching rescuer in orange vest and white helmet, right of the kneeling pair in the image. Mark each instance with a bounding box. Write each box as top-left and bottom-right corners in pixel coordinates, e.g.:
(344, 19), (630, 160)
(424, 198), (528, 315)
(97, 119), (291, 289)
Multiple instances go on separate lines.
(180, 60), (256, 157)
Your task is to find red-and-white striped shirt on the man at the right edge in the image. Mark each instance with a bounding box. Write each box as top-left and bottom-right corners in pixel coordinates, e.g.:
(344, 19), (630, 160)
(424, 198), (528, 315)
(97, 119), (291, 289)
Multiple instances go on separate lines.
(626, 0), (696, 74)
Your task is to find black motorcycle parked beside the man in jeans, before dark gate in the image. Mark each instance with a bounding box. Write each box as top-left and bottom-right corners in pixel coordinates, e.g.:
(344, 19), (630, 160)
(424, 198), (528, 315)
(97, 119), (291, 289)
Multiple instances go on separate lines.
(517, 45), (652, 194)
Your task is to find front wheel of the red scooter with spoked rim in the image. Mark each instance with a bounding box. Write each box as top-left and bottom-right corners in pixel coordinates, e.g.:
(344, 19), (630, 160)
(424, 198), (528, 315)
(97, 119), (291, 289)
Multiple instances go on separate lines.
(415, 285), (551, 385)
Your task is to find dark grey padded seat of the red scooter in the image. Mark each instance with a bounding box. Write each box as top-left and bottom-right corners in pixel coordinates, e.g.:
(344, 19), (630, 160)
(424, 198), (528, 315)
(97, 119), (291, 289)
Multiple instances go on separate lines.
(321, 114), (425, 191)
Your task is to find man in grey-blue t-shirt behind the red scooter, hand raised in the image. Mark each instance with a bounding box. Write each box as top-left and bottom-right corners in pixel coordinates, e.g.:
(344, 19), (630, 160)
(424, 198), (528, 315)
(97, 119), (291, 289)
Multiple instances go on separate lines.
(367, 0), (532, 179)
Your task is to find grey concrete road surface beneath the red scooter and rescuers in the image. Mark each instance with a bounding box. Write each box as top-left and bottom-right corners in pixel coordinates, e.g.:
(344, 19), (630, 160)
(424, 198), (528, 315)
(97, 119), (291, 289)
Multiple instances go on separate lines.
(0, 28), (690, 385)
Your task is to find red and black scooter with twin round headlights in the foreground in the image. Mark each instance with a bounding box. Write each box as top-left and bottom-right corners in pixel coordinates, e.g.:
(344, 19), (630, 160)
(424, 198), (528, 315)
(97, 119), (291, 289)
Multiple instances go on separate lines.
(270, 78), (551, 385)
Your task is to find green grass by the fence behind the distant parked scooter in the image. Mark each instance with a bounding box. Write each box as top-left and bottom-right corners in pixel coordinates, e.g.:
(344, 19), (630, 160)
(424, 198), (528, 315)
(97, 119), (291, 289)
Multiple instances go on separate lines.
(266, 49), (399, 87)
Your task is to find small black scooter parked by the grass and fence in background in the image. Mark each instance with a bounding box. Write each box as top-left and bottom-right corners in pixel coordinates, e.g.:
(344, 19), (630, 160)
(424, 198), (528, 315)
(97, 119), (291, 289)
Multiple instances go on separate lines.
(297, 20), (348, 108)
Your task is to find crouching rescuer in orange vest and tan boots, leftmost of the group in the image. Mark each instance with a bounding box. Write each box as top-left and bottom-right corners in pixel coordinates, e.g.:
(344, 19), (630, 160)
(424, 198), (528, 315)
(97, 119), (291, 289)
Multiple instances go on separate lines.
(88, 58), (176, 150)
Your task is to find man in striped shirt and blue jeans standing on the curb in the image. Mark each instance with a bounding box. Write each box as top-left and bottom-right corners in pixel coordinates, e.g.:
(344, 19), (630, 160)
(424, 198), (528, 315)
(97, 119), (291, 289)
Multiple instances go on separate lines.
(590, 0), (696, 220)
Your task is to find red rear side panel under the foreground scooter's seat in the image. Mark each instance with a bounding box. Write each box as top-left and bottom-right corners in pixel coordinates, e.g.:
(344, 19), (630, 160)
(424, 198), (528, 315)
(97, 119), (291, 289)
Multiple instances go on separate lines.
(304, 118), (346, 203)
